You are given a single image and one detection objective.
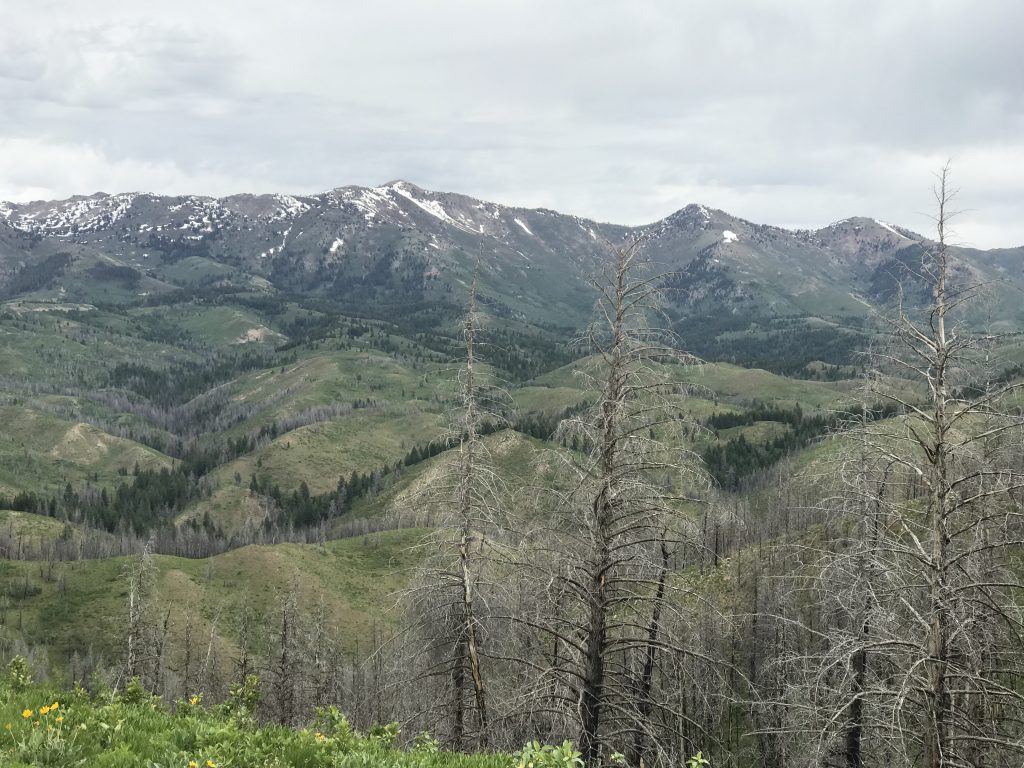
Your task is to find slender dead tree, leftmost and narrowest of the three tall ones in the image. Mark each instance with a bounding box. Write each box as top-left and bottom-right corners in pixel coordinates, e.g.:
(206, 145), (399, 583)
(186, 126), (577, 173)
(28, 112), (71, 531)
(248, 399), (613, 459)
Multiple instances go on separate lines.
(404, 267), (509, 750)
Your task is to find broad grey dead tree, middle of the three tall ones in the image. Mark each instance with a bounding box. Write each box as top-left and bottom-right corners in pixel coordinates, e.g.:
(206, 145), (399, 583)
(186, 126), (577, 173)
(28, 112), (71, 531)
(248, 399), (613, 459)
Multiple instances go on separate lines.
(520, 240), (705, 766)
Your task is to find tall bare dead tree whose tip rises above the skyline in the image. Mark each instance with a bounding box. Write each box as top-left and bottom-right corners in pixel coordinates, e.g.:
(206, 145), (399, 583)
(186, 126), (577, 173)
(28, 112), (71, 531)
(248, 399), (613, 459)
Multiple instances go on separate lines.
(774, 167), (1024, 768)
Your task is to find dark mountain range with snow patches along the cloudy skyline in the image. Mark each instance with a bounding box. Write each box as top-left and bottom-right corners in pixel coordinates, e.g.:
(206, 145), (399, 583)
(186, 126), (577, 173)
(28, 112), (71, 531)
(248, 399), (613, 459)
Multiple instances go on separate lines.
(0, 181), (1024, 369)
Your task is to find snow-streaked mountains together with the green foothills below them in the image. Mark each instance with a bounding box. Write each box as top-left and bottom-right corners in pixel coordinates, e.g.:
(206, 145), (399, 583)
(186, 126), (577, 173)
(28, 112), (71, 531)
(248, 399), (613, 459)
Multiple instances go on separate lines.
(0, 181), (1024, 708)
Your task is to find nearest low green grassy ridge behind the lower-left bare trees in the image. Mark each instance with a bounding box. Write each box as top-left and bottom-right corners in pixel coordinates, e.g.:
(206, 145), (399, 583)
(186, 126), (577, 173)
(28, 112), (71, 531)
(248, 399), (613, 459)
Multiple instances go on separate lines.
(0, 528), (426, 664)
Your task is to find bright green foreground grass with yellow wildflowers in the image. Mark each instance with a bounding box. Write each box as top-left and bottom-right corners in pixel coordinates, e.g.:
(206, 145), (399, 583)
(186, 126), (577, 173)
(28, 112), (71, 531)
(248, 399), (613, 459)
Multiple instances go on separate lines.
(0, 673), (512, 768)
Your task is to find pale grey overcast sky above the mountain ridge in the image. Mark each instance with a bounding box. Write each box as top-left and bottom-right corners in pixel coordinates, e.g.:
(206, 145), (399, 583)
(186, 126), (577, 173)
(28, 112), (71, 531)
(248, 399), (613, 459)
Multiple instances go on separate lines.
(0, 0), (1024, 248)
